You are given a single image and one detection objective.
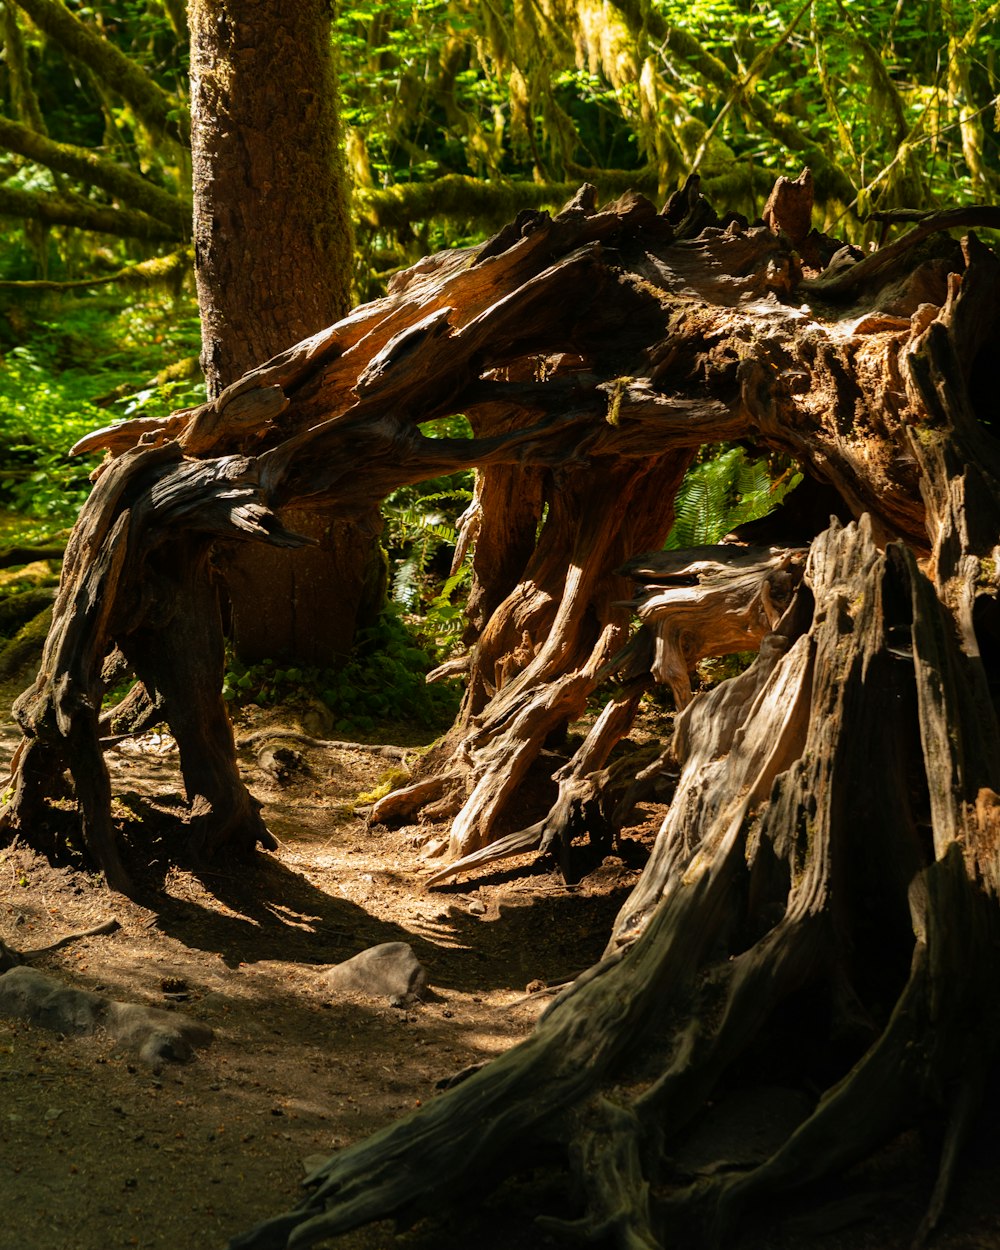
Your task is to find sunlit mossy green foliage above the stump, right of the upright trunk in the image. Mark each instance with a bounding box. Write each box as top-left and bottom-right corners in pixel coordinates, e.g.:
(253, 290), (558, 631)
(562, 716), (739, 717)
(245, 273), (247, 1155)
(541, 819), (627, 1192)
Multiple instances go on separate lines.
(338, 0), (1000, 291)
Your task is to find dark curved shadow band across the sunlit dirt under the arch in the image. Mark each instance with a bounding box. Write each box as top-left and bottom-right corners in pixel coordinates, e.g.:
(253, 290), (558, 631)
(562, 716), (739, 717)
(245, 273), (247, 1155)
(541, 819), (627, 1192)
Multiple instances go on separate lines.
(107, 805), (631, 993)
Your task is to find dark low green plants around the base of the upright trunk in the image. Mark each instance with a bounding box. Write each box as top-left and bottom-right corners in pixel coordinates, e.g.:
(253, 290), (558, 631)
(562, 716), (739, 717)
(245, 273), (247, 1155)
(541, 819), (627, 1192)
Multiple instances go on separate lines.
(223, 610), (460, 736)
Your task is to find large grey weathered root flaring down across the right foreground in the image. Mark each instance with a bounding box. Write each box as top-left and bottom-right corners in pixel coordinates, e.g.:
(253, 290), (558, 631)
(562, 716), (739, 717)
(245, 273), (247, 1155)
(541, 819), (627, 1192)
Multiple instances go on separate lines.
(233, 512), (1000, 1250)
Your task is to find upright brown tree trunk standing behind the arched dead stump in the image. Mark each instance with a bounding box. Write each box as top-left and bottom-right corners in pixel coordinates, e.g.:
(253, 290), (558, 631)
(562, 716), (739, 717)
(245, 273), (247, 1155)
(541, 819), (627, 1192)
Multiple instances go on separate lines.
(190, 0), (385, 665)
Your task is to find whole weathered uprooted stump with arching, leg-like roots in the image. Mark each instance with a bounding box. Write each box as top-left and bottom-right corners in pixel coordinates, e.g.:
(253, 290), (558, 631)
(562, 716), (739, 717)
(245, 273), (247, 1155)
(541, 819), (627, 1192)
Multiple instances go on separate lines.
(4, 178), (1000, 1250)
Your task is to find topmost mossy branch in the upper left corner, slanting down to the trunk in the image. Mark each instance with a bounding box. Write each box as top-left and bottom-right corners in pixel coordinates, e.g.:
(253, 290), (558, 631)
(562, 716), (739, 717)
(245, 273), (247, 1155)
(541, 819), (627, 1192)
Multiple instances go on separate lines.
(10, 0), (191, 146)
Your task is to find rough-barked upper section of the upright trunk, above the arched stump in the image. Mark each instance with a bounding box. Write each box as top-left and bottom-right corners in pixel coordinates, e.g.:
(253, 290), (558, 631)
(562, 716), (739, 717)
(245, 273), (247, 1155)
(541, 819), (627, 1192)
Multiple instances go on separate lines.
(190, 0), (351, 396)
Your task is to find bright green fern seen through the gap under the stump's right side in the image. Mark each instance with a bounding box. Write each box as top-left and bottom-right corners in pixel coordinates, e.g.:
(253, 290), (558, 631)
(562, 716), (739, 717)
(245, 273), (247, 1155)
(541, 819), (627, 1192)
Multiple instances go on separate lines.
(664, 446), (801, 551)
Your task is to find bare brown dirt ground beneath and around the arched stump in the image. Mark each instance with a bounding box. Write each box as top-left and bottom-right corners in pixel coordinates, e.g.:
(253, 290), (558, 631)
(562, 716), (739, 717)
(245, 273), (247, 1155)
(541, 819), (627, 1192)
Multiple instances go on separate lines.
(0, 685), (1000, 1250)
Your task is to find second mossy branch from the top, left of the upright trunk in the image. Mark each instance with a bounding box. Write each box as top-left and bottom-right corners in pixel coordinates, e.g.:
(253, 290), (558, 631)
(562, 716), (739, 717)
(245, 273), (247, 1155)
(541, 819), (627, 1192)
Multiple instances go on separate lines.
(0, 118), (191, 238)
